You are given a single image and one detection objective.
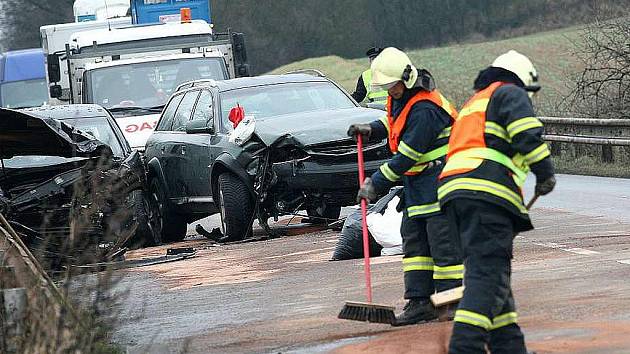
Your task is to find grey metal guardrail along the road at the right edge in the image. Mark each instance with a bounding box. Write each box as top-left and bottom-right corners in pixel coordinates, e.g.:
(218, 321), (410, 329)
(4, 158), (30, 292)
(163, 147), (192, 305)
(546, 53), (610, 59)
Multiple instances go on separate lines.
(539, 117), (630, 146)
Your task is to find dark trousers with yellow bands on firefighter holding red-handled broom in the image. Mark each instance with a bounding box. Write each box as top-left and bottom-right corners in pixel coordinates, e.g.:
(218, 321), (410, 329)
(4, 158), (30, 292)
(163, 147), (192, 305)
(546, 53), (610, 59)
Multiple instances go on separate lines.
(400, 214), (464, 299)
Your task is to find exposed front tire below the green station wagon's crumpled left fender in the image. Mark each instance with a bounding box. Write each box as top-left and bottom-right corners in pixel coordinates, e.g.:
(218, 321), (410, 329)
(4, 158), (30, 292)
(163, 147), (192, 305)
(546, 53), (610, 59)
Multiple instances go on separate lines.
(217, 172), (254, 241)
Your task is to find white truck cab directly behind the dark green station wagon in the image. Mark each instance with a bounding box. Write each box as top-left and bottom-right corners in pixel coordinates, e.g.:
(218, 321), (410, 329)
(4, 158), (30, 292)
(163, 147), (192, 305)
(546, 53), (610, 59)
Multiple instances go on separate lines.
(49, 20), (249, 150)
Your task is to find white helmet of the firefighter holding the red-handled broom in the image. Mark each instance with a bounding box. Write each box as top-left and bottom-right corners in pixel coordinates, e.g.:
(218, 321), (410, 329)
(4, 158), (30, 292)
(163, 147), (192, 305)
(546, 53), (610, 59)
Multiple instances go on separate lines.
(371, 47), (418, 90)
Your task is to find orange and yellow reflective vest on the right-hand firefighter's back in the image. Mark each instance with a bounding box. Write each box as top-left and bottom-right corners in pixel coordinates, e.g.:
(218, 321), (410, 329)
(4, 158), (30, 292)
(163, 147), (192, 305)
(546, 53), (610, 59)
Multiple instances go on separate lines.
(440, 82), (529, 187)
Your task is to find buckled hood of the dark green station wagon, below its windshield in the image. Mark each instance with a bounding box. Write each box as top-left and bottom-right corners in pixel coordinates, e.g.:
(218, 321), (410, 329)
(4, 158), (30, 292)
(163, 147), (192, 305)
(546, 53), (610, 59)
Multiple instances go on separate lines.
(254, 107), (384, 146)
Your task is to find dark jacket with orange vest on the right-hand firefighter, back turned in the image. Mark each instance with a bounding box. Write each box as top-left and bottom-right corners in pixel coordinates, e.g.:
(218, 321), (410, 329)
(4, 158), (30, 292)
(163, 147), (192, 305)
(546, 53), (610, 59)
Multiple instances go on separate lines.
(438, 72), (554, 232)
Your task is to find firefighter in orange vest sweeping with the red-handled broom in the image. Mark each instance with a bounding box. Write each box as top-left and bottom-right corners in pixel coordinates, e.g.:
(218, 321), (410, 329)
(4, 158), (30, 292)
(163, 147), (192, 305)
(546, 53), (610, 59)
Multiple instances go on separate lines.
(348, 47), (463, 326)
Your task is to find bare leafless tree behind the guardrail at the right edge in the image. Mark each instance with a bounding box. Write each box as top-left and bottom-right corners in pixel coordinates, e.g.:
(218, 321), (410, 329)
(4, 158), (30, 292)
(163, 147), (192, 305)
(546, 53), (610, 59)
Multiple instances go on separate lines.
(567, 17), (630, 118)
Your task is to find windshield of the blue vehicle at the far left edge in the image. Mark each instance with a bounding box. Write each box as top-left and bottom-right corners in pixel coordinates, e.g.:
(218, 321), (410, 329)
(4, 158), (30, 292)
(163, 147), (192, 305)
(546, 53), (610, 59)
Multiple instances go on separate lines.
(0, 79), (48, 108)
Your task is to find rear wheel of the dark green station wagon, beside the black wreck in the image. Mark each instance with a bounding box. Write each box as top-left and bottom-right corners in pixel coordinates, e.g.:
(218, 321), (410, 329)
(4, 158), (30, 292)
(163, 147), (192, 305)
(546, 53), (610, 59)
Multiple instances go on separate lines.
(149, 179), (187, 242)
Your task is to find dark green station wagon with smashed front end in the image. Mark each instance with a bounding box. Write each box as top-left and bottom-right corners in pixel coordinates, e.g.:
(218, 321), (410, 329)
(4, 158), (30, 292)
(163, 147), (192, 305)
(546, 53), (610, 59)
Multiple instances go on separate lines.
(145, 73), (390, 240)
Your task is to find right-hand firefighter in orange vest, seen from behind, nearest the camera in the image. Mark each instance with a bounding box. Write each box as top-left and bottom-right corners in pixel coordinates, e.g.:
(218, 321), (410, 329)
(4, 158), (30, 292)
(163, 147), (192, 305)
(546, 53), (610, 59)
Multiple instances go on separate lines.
(438, 50), (556, 354)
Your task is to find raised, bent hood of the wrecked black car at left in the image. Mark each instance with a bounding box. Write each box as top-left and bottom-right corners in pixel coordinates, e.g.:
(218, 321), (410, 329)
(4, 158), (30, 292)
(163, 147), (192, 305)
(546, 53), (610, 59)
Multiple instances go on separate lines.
(0, 108), (111, 159)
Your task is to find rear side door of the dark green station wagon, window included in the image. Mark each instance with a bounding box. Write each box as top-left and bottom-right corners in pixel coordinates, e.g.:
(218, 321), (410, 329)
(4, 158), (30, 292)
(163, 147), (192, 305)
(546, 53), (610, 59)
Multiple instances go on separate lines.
(160, 90), (199, 205)
